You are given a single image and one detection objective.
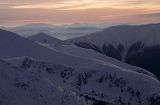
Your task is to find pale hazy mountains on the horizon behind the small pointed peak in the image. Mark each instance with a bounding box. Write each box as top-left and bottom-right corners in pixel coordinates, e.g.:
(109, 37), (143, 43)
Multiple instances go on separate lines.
(3, 23), (106, 39)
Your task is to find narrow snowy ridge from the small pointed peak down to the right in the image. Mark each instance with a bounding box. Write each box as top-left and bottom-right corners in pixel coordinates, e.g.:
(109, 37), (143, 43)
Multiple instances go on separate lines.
(27, 32), (155, 77)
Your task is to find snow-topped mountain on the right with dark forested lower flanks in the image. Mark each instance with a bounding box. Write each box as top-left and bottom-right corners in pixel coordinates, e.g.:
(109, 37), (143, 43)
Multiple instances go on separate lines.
(68, 24), (160, 77)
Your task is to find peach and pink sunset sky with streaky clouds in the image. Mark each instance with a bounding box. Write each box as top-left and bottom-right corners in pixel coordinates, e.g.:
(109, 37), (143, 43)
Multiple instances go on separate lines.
(0, 0), (160, 26)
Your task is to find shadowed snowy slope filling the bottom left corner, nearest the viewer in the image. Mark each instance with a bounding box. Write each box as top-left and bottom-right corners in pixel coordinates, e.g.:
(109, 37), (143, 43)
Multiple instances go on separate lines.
(0, 60), (85, 105)
